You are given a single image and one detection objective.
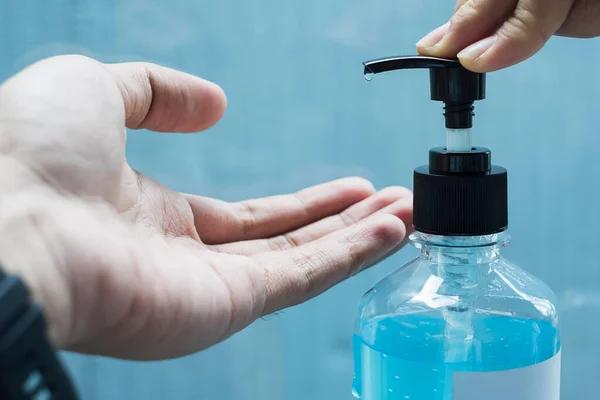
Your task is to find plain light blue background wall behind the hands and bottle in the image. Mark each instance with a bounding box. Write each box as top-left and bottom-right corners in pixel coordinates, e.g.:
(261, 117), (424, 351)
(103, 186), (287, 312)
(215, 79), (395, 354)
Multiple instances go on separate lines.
(0, 0), (600, 400)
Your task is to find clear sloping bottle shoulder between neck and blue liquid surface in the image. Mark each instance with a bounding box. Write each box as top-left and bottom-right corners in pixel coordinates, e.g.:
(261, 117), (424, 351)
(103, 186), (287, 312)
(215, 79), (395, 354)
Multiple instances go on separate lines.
(359, 256), (558, 325)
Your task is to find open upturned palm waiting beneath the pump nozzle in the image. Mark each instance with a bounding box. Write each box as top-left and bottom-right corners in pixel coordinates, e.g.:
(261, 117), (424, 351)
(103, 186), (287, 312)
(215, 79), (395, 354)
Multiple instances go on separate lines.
(0, 56), (412, 359)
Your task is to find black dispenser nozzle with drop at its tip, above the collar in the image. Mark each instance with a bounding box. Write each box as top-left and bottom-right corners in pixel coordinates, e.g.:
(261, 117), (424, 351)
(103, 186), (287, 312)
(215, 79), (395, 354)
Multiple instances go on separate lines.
(363, 56), (485, 129)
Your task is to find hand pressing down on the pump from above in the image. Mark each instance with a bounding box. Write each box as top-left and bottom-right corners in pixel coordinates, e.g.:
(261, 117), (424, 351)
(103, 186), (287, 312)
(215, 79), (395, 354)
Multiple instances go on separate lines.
(417, 0), (600, 72)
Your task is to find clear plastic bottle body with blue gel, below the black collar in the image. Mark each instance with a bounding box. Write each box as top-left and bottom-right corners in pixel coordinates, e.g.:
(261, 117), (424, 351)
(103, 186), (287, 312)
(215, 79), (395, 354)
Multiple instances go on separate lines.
(353, 233), (561, 400)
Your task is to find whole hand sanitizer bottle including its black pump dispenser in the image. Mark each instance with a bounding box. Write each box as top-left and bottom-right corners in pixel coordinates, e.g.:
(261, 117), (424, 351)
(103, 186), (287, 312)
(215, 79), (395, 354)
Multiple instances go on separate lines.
(353, 56), (561, 400)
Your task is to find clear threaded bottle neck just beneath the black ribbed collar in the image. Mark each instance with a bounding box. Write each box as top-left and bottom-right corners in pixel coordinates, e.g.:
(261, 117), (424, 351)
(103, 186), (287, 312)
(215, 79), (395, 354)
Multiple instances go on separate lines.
(411, 232), (510, 266)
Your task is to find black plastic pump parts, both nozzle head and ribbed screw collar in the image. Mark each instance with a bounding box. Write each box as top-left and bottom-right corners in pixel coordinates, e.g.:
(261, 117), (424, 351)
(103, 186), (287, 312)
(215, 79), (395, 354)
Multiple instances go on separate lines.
(363, 56), (508, 236)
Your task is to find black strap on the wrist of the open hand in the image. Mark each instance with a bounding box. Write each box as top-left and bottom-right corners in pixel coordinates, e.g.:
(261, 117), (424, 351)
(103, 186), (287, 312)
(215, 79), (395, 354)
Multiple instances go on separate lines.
(0, 270), (78, 400)
